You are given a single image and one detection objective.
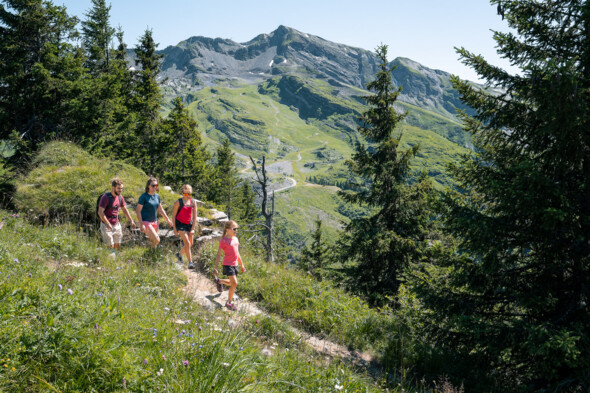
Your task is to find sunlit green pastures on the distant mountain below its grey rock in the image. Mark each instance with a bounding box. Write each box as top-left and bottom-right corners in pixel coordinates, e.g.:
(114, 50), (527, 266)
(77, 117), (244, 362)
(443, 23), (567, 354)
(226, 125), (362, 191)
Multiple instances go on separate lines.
(189, 83), (468, 234)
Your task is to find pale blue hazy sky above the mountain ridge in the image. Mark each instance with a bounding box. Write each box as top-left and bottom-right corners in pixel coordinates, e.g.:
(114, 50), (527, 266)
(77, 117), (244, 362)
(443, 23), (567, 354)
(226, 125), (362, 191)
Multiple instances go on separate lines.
(53, 0), (508, 80)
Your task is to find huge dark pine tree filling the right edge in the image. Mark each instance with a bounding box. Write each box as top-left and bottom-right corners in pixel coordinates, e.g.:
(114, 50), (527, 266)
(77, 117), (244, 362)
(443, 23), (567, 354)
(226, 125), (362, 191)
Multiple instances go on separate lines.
(415, 0), (590, 392)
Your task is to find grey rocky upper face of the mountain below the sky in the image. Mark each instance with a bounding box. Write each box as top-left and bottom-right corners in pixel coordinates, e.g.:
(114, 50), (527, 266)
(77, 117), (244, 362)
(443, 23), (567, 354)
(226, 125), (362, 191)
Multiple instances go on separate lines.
(160, 26), (472, 120)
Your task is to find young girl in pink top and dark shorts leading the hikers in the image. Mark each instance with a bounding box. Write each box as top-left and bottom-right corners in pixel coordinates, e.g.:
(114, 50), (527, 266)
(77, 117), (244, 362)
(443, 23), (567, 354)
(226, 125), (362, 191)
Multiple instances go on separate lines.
(213, 220), (246, 311)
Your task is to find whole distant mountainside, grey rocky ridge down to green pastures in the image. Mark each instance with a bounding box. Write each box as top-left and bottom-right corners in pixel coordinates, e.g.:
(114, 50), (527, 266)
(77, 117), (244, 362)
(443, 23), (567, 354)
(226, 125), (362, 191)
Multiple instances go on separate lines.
(154, 26), (472, 239)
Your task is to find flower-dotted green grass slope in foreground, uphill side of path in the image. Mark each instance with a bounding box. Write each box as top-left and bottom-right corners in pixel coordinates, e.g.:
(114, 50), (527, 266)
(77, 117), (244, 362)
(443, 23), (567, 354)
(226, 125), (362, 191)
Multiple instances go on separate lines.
(0, 213), (396, 392)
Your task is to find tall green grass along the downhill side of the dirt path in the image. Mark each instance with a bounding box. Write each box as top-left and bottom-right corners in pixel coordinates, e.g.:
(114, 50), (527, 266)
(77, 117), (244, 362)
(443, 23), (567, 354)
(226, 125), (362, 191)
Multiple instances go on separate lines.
(201, 243), (411, 356)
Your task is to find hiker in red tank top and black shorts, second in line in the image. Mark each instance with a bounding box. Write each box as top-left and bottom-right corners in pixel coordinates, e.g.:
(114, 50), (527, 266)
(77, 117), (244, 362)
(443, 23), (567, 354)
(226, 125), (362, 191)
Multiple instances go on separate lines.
(172, 184), (199, 269)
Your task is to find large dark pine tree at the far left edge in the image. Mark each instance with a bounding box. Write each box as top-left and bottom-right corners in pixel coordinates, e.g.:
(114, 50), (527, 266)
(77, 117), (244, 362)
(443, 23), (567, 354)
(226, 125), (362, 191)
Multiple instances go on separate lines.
(0, 0), (84, 159)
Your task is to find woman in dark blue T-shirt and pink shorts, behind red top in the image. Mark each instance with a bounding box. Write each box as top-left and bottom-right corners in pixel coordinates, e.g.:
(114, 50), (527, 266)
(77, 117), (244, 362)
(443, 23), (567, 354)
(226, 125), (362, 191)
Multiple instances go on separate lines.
(135, 176), (172, 249)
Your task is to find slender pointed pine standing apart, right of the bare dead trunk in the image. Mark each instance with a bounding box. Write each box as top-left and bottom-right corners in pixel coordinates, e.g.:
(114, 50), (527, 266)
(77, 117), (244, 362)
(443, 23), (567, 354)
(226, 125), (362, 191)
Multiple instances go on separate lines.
(340, 46), (427, 304)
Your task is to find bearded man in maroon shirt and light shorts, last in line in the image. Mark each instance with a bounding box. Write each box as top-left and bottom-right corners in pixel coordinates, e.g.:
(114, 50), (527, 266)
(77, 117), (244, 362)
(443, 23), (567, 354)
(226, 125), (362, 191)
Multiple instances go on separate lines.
(97, 178), (135, 250)
